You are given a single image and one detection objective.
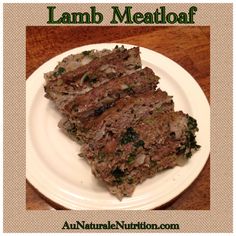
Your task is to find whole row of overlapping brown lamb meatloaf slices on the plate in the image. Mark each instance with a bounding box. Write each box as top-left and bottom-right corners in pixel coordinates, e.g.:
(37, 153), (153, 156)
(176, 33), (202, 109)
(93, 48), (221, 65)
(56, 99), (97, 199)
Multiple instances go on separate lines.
(45, 46), (200, 200)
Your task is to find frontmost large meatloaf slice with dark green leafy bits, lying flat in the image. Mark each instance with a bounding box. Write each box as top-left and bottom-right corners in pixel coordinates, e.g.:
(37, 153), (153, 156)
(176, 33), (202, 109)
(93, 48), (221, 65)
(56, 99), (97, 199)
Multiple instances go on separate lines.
(82, 111), (199, 199)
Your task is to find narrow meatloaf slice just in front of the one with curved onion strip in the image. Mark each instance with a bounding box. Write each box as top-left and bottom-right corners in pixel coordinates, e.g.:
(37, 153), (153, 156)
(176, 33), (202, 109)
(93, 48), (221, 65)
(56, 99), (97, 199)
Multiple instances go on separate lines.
(62, 67), (159, 120)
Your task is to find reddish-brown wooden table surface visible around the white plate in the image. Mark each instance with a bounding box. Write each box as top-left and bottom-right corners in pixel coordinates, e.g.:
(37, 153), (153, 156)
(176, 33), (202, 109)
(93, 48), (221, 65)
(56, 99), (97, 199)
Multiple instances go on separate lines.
(26, 26), (210, 210)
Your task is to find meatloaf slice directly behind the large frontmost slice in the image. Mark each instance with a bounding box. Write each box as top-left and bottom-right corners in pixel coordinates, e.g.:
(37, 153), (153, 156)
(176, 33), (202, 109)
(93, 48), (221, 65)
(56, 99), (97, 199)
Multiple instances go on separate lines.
(59, 89), (174, 145)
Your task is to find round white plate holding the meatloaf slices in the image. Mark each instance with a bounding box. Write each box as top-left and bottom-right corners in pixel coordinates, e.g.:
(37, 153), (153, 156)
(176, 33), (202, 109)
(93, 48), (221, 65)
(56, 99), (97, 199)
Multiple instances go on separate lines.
(26, 43), (210, 210)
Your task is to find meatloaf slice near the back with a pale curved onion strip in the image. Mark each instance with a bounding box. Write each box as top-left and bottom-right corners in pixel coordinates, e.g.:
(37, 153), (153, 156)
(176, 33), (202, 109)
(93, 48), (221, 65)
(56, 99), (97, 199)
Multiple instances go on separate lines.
(44, 47), (141, 109)
